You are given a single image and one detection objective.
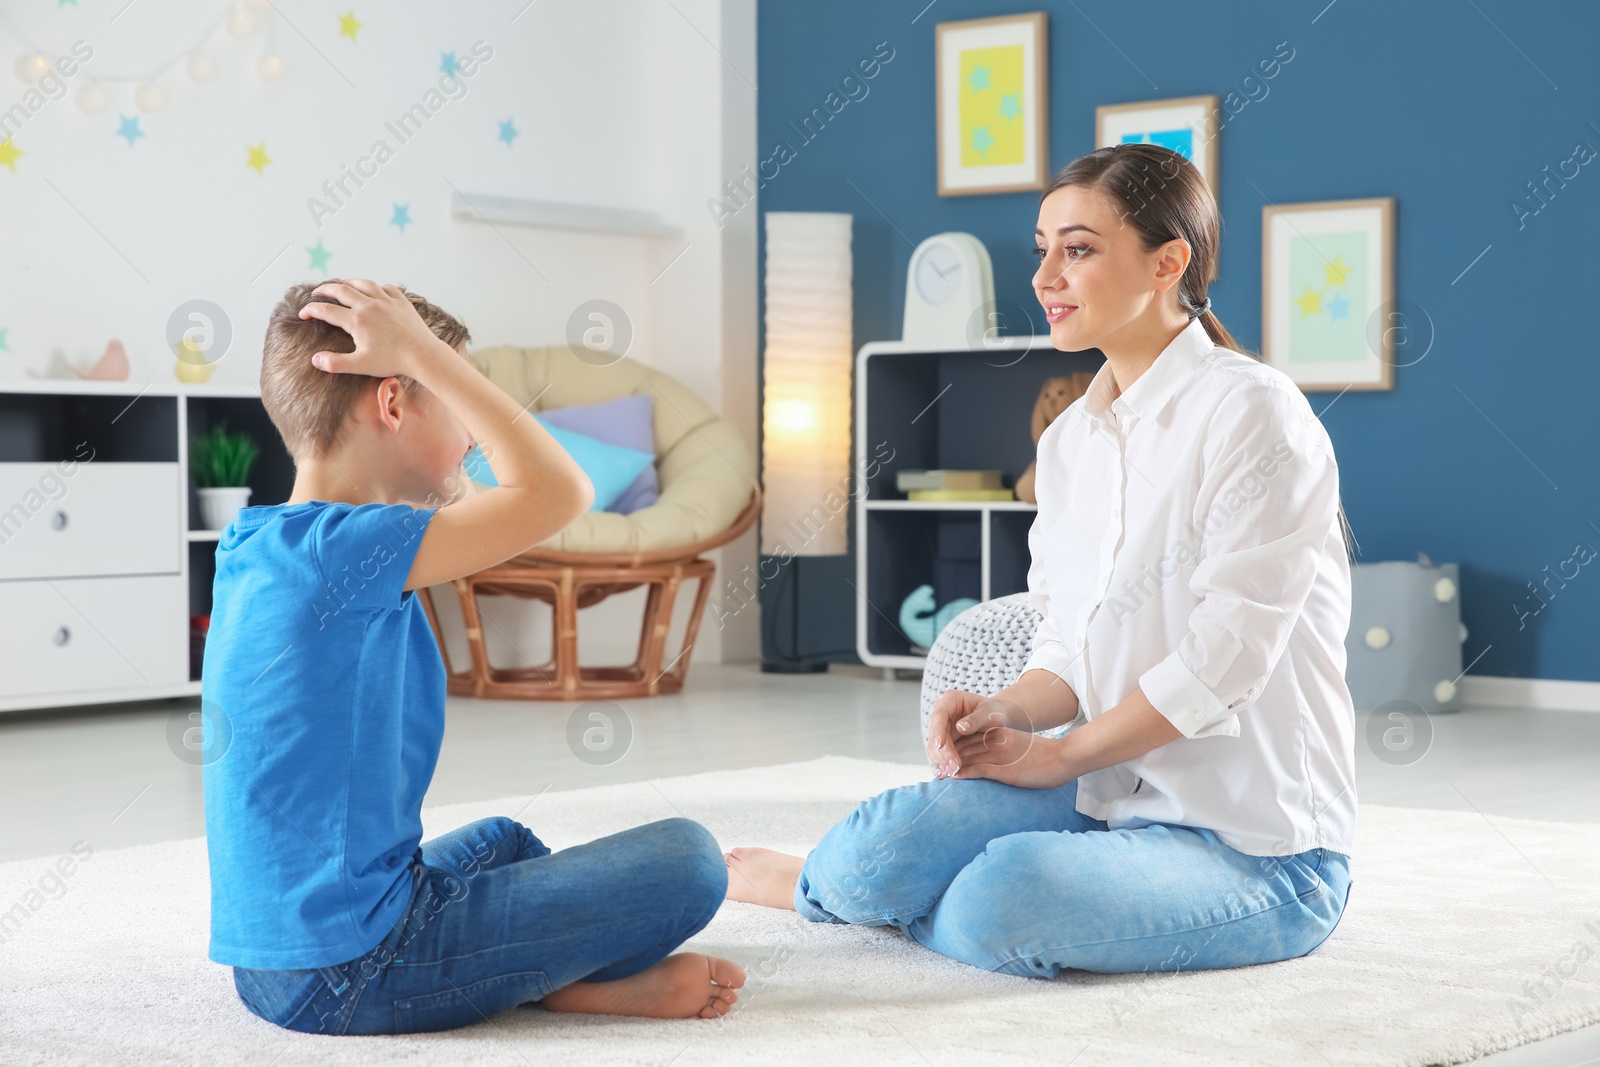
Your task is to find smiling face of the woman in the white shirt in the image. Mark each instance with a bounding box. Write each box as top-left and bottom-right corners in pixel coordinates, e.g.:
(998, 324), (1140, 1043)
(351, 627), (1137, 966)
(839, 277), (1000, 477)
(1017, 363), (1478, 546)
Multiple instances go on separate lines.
(1034, 186), (1182, 352)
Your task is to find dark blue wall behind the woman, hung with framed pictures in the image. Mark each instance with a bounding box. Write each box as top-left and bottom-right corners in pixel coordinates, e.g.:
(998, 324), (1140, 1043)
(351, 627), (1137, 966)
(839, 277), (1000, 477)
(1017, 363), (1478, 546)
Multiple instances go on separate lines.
(758, 0), (1600, 680)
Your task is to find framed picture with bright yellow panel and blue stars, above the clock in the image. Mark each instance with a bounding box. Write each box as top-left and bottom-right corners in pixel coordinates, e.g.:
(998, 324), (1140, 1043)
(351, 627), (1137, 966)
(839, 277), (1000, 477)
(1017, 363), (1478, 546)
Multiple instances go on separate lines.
(933, 11), (1050, 197)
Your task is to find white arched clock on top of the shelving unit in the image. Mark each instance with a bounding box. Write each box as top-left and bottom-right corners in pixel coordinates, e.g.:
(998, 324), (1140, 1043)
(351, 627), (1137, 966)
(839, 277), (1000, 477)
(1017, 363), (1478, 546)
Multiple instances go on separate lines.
(901, 232), (995, 349)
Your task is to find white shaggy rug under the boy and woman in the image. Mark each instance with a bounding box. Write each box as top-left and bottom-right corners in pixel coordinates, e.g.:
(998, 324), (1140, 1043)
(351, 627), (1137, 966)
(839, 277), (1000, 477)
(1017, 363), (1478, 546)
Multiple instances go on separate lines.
(0, 757), (1600, 1067)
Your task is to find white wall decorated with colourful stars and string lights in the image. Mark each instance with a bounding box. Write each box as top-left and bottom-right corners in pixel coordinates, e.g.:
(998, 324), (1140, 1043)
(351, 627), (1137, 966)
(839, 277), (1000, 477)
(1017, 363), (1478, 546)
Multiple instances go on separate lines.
(0, 0), (758, 661)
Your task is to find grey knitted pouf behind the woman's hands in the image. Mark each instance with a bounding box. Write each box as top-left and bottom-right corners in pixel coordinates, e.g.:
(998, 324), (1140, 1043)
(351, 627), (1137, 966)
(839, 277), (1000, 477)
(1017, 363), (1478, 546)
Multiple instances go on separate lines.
(922, 592), (1038, 742)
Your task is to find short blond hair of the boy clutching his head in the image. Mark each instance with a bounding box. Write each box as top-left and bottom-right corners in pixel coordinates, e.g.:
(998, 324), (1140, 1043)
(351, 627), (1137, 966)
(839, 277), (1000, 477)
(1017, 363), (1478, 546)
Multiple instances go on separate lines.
(261, 278), (472, 464)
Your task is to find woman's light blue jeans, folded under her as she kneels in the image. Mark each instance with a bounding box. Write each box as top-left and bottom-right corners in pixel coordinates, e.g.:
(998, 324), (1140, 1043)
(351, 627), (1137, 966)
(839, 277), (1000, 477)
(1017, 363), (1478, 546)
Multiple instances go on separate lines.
(795, 779), (1350, 977)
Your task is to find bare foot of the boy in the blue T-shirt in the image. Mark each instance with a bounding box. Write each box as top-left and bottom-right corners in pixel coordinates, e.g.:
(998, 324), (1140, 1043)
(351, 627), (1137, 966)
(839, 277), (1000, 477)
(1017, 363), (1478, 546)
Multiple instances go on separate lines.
(542, 952), (744, 1019)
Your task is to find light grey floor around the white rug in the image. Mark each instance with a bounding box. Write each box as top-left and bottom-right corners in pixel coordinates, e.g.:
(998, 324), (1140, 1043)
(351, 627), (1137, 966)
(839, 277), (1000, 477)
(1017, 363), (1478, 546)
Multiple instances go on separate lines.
(0, 664), (1600, 1067)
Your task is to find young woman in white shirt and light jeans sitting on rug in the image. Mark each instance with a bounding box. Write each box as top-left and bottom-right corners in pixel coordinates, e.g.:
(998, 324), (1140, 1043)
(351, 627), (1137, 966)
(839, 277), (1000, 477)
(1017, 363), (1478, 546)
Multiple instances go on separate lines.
(726, 144), (1355, 977)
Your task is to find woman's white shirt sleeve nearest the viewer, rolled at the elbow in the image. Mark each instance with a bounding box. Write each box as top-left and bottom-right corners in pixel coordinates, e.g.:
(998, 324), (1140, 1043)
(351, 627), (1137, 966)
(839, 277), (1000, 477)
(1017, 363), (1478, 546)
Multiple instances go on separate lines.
(1139, 382), (1339, 737)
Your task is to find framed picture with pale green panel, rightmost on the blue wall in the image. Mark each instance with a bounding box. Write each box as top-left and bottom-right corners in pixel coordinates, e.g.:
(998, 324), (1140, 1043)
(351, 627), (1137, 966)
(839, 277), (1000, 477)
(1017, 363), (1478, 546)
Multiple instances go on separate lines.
(1261, 197), (1395, 392)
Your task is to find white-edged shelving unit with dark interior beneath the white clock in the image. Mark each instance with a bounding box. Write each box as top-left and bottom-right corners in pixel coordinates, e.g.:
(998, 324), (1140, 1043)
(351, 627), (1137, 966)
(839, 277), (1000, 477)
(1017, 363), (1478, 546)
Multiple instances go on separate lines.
(854, 336), (1102, 669)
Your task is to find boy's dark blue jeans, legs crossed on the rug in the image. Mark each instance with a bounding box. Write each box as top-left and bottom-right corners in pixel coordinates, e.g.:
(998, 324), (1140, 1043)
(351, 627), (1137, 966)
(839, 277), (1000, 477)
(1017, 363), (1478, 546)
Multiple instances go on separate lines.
(234, 817), (728, 1033)
